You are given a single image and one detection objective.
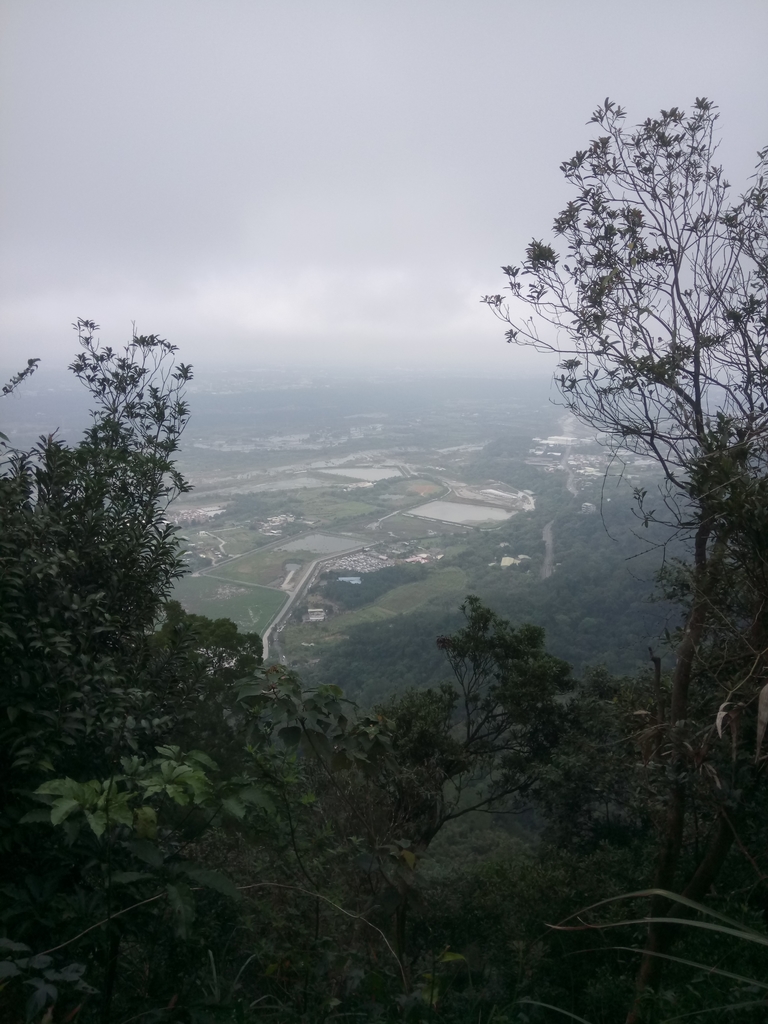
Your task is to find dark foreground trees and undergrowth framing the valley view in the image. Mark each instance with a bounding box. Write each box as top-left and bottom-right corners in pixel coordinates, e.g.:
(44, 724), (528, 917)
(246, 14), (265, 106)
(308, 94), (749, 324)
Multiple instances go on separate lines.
(0, 99), (768, 1024)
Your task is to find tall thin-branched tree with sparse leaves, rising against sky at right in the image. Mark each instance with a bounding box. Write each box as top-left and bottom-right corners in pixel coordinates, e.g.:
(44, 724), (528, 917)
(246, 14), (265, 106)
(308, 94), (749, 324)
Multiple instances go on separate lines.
(483, 99), (768, 1019)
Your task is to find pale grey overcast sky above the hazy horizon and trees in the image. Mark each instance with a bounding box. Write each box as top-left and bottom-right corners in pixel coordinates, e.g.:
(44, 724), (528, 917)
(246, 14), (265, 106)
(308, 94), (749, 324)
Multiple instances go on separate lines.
(0, 0), (768, 372)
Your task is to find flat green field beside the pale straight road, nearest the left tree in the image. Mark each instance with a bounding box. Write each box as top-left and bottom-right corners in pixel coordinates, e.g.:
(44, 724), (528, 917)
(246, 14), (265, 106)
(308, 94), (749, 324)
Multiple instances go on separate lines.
(172, 575), (287, 633)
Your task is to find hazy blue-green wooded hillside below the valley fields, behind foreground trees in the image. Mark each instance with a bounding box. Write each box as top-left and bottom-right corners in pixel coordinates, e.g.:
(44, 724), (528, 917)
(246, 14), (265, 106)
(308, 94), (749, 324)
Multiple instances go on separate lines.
(289, 495), (680, 702)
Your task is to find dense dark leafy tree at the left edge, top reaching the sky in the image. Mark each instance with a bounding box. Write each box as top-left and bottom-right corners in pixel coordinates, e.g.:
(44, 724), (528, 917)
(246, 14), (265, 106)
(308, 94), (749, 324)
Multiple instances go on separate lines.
(0, 321), (190, 790)
